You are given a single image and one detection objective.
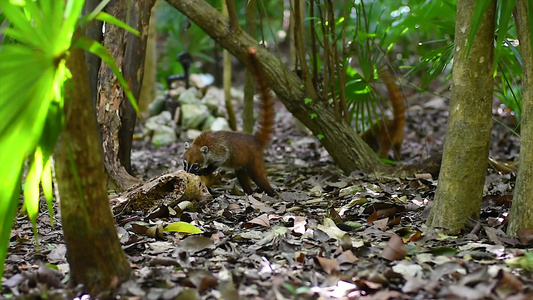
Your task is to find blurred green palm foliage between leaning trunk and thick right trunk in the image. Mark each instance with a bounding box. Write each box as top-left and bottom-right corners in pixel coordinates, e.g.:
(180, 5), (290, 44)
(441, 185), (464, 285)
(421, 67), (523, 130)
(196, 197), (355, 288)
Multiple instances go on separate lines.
(308, 0), (456, 131)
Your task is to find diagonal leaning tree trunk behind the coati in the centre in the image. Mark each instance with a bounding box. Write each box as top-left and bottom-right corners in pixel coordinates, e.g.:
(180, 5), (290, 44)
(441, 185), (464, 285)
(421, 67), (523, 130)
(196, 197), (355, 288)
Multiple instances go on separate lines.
(167, 0), (387, 173)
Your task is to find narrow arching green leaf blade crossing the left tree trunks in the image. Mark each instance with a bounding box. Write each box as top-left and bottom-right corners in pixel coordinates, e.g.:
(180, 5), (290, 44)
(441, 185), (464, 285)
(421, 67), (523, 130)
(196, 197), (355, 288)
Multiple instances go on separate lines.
(74, 36), (141, 116)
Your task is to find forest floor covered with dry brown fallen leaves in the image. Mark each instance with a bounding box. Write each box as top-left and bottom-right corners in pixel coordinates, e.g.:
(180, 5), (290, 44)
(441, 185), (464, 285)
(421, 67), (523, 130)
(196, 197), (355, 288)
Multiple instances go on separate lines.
(0, 85), (533, 300)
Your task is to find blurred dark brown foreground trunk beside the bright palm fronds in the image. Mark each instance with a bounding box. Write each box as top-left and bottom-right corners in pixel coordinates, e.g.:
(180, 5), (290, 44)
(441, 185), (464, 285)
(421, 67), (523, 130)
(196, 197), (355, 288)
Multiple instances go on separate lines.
(55, 49), (130, 295)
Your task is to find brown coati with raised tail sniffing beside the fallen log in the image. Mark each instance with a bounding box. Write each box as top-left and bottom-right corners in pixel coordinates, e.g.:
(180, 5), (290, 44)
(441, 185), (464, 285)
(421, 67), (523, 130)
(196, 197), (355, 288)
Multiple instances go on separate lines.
(183, 47), (276, 196)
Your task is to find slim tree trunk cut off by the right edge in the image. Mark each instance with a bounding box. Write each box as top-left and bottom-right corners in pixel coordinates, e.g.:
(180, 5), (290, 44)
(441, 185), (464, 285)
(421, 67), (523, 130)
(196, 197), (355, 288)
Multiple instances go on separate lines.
(507, 0), (533, 236)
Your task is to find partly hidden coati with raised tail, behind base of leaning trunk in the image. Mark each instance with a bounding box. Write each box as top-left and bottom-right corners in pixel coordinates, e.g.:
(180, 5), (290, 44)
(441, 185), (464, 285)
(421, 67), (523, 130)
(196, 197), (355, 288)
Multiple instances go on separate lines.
(361, 70), (405, 160)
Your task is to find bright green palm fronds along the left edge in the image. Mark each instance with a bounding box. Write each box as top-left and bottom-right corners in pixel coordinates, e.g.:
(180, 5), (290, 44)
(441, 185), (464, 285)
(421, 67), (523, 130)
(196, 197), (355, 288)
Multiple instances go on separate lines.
(0, 0), (138, 277)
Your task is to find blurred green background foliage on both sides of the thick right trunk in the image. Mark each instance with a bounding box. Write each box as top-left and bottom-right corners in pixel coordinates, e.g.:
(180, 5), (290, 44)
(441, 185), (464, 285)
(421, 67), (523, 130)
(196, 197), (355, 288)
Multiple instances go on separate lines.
(313, 0), (520, 131)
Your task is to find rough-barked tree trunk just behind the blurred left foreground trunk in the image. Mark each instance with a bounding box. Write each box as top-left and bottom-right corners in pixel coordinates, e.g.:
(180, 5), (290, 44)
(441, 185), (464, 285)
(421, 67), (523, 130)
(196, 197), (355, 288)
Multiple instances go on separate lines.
(97, 0), (155, 191)
